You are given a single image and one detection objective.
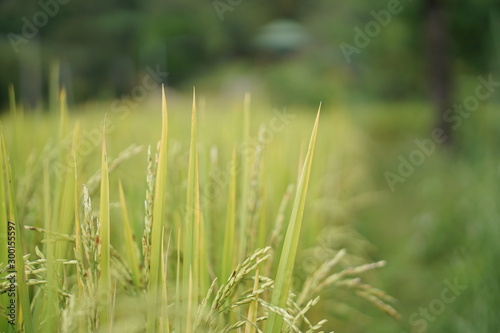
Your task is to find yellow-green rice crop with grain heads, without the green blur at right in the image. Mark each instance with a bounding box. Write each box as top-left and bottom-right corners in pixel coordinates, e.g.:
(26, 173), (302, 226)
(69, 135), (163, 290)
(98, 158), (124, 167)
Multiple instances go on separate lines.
(0, 86), (399, 332)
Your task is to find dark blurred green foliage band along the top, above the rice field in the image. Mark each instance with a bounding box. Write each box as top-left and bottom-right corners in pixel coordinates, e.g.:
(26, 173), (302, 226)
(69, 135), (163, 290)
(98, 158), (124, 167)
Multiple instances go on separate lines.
(0, 0), (500, 106)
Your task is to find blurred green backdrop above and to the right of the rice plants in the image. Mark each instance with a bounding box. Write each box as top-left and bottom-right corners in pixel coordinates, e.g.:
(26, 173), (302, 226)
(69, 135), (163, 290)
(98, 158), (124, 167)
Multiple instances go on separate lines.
(0, 0), (500, 333)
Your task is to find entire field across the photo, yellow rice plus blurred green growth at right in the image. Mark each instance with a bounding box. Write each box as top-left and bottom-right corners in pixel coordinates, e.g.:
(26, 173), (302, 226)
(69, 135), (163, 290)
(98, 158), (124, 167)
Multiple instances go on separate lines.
(0, 84), (500, 333)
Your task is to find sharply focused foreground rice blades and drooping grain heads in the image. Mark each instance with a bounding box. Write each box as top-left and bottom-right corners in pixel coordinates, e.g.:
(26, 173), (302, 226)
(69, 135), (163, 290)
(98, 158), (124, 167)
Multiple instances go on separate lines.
(0, 84), (397, 333)
